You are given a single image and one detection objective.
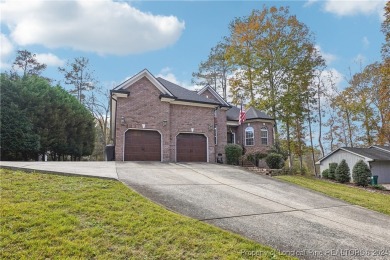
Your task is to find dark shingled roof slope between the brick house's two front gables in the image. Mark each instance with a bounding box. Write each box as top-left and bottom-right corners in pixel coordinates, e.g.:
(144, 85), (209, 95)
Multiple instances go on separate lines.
(157, 77), (224, 105)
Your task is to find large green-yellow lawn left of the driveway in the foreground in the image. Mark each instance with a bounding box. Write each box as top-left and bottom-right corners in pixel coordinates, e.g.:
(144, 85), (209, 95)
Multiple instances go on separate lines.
(0, 169), (291, 259)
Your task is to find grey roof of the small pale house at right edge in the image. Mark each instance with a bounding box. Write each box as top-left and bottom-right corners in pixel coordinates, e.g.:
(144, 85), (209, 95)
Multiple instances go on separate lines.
(317, 146), (390, 164)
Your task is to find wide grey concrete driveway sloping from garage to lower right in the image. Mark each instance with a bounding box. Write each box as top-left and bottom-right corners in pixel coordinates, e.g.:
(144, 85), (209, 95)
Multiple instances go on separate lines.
(117, 162), (390, 259)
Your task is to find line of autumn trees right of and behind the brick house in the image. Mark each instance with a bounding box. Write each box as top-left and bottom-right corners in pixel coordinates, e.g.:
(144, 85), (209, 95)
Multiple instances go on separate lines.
(193, 2), (390, 174)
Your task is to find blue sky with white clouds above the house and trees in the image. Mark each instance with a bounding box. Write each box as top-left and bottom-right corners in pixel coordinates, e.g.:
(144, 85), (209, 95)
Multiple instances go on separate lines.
(0, 0), (385, 98)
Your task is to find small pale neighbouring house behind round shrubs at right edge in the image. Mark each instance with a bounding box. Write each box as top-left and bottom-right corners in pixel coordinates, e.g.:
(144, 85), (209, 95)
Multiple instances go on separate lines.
(316, 145), (390, 184)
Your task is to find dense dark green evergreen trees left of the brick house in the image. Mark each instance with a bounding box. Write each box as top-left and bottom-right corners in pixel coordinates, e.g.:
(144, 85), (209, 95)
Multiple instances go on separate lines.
(0, 50), (95, 160)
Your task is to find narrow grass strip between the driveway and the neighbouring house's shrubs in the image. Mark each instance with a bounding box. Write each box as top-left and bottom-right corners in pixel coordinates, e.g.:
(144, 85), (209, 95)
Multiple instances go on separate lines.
(276, 175), (390, 215)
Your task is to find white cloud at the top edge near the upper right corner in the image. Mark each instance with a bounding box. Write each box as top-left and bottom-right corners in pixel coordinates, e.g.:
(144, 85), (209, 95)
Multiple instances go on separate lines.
(324, 0), (386, 16)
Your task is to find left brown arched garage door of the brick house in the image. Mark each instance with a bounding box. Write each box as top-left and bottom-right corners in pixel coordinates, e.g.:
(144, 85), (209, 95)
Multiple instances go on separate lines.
(124, 130), (161, 161)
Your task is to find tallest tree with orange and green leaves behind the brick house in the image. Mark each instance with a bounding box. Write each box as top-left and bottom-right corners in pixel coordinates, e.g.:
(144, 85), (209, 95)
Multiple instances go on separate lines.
(227, 7), (324, 172)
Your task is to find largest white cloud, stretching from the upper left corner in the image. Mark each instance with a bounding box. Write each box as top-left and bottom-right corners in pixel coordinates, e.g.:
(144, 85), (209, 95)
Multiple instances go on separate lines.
(0, 0), (185, 55)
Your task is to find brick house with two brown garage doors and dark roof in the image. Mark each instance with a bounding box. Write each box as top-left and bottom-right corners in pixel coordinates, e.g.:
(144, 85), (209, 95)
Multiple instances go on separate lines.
(111, 69), (274, 162)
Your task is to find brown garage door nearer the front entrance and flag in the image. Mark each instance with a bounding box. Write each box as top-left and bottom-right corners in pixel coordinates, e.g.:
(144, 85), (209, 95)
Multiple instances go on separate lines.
(176, 134), (207, 162)
